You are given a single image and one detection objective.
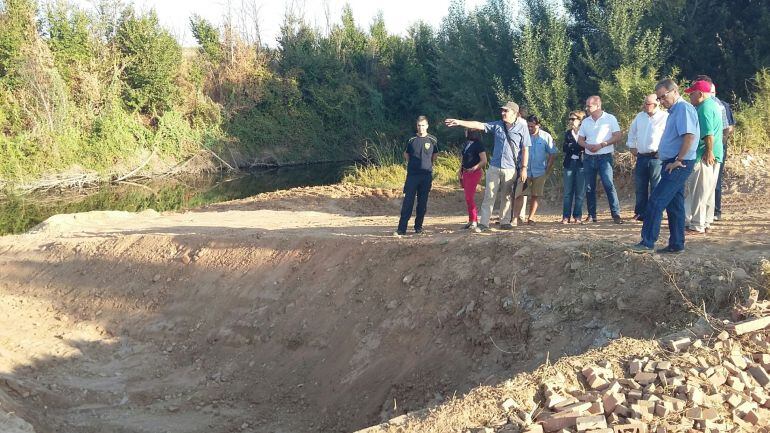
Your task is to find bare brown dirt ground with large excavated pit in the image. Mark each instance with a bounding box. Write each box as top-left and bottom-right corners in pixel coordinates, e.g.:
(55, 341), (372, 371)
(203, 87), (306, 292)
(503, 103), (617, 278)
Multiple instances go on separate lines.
(0, 156), (770, 433)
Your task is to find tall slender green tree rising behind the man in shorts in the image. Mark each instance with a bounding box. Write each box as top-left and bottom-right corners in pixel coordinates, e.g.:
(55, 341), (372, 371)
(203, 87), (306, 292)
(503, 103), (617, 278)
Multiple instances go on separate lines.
(519, 0), (570, 133)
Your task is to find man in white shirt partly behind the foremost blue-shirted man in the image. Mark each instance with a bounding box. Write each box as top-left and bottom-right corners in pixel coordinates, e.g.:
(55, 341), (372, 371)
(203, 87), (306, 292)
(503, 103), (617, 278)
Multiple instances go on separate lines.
(626, 93), (668, 221)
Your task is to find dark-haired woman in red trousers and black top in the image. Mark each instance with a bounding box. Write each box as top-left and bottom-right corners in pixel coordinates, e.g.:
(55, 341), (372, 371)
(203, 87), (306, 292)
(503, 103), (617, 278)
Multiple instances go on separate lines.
(457, 129), (487, 233)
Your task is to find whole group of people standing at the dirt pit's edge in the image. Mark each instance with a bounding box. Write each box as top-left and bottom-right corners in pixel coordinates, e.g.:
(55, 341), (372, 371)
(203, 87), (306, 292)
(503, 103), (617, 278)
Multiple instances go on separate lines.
(397, 75), (734, 252)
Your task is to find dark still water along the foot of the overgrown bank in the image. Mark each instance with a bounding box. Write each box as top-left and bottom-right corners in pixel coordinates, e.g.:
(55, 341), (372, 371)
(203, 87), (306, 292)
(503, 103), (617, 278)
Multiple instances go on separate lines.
(0, 164), (349, 235)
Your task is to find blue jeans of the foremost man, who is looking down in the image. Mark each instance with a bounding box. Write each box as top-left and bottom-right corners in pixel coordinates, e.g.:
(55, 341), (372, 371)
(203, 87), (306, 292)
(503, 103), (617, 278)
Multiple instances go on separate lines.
(641, 158), (695, 251)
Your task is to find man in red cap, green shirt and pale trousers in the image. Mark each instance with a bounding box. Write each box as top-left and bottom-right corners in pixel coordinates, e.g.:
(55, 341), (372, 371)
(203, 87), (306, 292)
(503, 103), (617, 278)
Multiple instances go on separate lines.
(684, 80), (724, 235)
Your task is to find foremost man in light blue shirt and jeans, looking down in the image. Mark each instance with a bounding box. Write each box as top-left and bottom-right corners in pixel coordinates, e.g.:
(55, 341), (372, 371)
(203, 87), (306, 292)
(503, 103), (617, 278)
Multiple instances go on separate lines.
(631, 79), (700, 253)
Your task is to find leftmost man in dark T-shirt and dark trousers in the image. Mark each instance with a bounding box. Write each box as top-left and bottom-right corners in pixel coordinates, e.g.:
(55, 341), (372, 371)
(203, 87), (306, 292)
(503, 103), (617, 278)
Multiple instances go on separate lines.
(396, 116), (438, 235)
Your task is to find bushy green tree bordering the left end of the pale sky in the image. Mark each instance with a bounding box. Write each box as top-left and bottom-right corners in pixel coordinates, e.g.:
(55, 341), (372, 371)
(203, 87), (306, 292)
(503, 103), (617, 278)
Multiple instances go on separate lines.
(115, 11), (182, 116)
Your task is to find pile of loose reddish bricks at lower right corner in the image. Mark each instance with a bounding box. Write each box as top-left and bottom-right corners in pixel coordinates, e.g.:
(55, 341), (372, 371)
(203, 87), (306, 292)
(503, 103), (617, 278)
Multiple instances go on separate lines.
(523, 299), (770, 433)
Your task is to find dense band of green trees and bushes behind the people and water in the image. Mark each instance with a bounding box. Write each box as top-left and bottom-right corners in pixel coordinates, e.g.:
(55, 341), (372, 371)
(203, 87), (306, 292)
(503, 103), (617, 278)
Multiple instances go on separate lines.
(0, 0), (770, 184)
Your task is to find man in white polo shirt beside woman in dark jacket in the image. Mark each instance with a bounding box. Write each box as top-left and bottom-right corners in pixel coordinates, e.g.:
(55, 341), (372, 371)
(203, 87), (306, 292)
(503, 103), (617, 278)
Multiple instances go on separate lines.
(578, 95), (623, 224)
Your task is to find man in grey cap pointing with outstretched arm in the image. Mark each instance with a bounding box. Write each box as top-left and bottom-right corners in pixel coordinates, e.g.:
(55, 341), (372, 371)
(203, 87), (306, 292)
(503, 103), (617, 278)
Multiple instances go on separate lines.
(444, 101), (531, 231)
